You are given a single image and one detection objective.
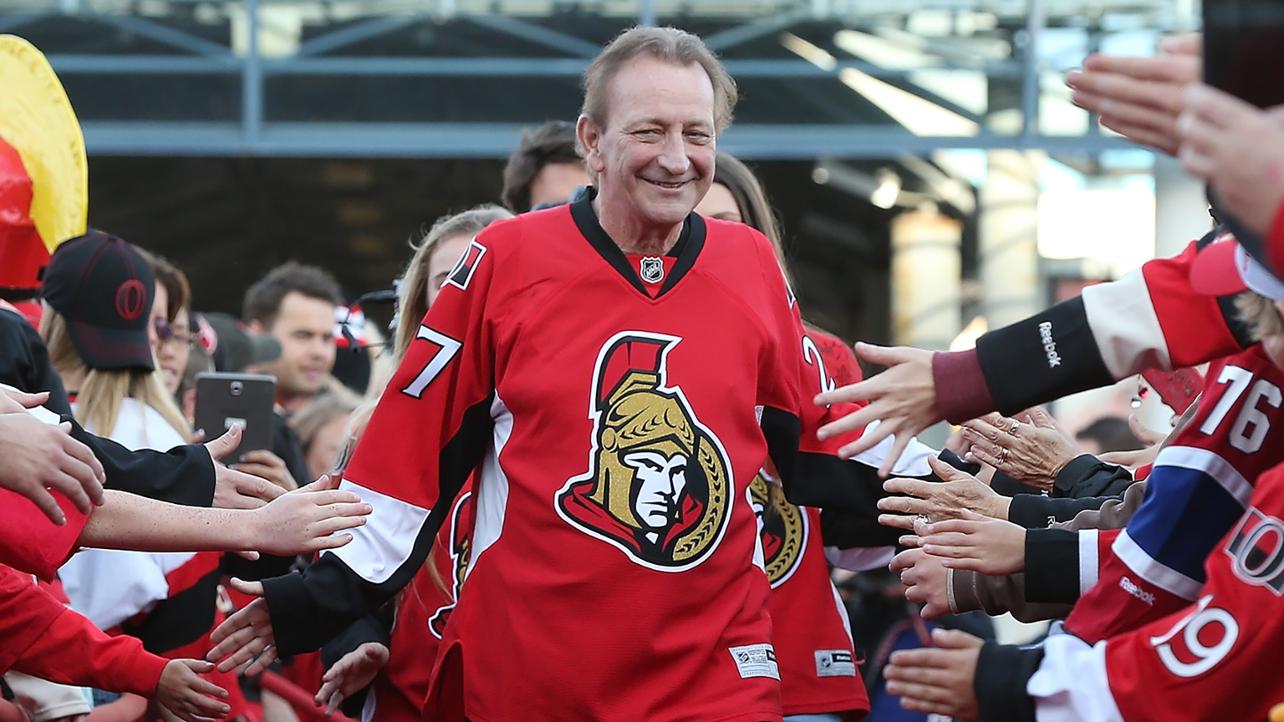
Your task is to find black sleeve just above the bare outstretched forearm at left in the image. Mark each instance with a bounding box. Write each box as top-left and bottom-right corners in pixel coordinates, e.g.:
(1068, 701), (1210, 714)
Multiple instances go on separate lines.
(64, 418), (214, 506)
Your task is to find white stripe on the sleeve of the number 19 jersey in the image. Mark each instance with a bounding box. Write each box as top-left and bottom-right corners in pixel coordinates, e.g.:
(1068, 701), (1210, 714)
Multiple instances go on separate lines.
(1026, 633), (1124, 722)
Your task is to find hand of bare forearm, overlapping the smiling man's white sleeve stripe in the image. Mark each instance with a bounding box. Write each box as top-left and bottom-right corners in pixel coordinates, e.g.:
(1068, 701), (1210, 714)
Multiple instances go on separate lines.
(250, 477), (374, 556)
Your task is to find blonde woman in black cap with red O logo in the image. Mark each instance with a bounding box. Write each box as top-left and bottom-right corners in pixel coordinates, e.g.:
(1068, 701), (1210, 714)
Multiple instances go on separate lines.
(40, 231), (244, 719)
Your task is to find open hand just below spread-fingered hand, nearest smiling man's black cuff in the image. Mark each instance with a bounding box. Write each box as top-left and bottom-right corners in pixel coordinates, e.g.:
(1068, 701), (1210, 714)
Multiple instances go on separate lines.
(878, 459), (1012, 529)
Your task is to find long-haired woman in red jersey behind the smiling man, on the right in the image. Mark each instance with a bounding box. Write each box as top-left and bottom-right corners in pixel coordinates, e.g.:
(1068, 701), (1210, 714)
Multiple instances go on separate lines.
(696, 152), (886, 722)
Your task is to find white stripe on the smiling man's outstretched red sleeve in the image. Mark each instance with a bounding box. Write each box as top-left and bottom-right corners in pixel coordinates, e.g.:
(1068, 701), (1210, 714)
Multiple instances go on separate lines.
(326, 479), (429, 585)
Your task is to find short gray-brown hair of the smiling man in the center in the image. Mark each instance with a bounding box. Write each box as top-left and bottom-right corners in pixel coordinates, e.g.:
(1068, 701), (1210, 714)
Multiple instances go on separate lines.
(580, 26), (738, 132)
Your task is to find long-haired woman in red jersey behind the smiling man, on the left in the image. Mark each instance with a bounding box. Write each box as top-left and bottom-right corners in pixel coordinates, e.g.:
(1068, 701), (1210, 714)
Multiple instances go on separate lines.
(317, 204), (512, 722)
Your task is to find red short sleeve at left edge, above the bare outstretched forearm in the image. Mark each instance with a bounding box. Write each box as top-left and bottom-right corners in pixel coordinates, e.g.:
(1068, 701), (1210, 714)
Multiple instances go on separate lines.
(0, 489), (89, 581)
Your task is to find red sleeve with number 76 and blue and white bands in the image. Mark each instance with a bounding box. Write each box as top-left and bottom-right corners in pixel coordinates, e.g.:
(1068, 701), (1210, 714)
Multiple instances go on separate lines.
(1066, 344), (1284, 642)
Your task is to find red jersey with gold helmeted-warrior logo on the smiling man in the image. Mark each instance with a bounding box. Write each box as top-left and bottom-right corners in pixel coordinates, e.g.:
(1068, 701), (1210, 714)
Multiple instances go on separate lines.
(265, 199), (926, 722)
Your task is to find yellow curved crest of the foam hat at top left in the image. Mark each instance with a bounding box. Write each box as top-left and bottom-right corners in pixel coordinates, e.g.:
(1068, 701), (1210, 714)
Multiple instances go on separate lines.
(0, 35), (89, 253)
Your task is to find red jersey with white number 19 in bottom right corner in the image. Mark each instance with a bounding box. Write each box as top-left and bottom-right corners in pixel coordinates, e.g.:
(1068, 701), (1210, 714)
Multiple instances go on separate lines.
(1026, 466), (1284, 722)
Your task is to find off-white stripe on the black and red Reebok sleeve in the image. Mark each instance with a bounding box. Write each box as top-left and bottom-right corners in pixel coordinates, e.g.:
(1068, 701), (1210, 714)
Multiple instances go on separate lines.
(1082, 269), (1172, 379)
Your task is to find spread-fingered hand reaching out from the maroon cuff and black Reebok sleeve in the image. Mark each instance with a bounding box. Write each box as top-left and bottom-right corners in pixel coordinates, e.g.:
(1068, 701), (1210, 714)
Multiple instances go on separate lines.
(815, 343), (942, 477)
